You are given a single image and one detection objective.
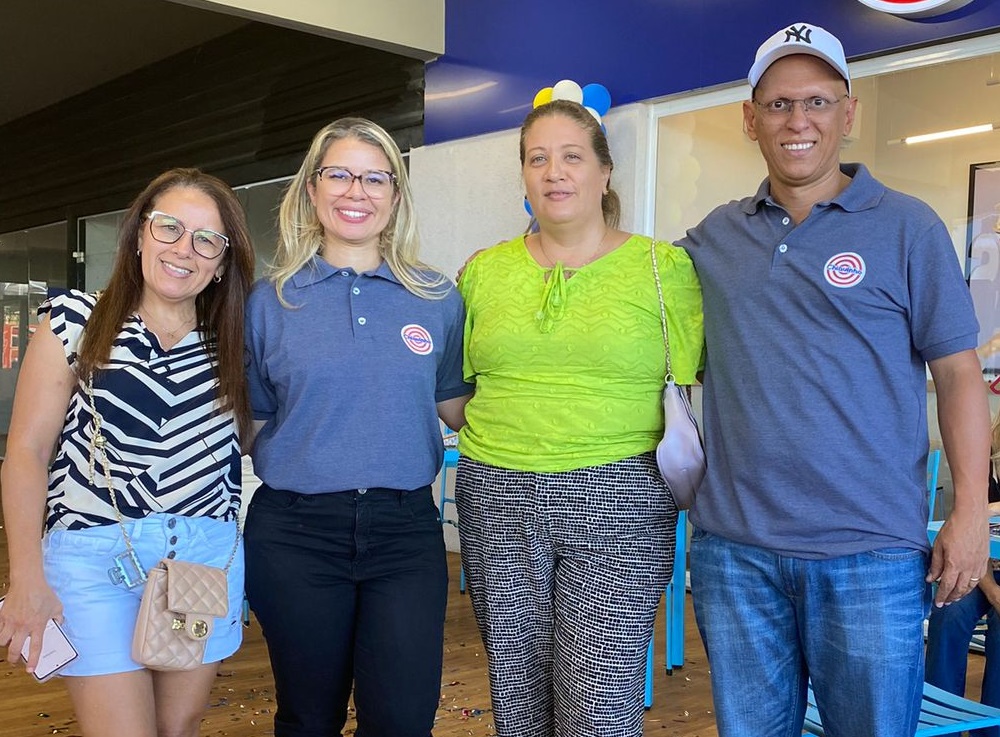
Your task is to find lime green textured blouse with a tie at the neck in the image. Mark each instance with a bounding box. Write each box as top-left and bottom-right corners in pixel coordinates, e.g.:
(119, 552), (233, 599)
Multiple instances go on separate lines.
(459, 235), (704, 471)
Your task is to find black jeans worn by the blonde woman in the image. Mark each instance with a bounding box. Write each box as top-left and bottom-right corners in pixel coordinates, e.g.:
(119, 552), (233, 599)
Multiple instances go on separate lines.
(244, 485), (448, 737)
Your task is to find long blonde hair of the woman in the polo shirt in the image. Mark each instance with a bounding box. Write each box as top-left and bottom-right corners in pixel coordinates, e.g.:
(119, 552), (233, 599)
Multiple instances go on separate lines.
(268, 118), (452, 307)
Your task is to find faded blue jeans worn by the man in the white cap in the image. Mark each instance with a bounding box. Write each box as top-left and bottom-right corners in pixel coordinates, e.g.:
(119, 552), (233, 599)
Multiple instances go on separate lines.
(691, 528), (930, 737)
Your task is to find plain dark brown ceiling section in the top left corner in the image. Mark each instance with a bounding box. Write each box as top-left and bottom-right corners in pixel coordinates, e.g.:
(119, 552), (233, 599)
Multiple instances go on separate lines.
(0, 0), (248, 125)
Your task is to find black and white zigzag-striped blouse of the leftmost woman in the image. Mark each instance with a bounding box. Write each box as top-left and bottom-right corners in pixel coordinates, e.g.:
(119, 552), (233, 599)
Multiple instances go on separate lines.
(39, 291), (240, 530)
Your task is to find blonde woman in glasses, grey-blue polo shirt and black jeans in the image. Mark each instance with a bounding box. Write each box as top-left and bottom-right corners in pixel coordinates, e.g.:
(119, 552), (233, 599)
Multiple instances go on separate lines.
(245, 118), (472, 737)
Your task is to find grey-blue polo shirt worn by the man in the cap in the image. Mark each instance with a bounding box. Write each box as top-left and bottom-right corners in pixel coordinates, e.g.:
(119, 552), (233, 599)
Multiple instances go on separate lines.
(678, 164), (978, 558)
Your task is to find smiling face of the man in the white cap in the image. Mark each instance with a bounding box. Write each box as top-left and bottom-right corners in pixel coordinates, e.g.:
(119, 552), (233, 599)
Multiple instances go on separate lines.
(743, 54), (857, 202)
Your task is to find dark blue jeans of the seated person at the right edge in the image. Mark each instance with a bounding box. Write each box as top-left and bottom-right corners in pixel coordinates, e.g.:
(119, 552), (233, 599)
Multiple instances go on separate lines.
(927, 573), (1000, 737)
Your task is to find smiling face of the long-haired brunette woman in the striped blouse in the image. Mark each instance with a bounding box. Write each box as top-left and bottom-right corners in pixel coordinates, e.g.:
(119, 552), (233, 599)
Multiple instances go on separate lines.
(138, 187), (226, 309)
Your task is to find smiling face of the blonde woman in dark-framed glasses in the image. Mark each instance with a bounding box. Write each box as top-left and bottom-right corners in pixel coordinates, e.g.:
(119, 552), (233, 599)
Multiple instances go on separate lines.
(306, 138), (399, 253)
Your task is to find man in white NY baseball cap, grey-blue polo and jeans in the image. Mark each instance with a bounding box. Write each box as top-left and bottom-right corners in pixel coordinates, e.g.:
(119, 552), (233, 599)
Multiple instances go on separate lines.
(679, 17), (990, 737)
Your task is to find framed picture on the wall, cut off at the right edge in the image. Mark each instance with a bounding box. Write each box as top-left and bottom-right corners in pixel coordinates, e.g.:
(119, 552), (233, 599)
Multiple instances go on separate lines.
(966, 161), (1000, 375)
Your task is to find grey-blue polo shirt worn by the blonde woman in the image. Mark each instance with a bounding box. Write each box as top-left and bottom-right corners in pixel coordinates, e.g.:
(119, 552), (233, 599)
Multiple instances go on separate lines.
(246, 257), (473, 494)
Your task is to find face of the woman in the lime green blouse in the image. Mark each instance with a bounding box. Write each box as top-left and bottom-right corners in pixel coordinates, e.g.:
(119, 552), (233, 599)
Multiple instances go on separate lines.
(521, 114), (611, 227)
